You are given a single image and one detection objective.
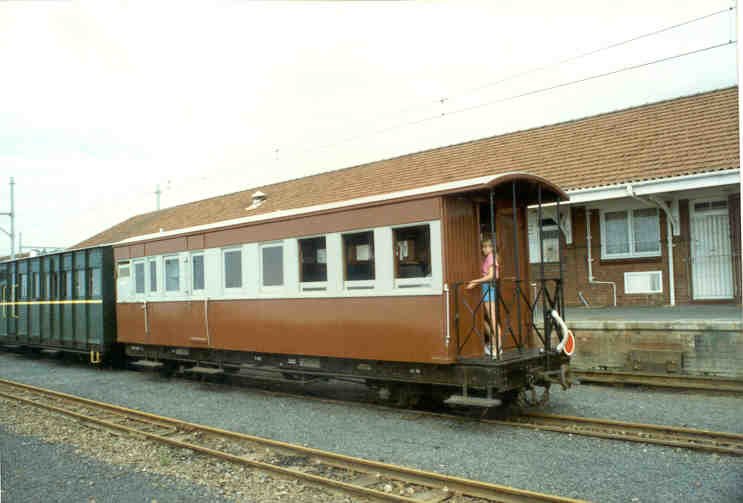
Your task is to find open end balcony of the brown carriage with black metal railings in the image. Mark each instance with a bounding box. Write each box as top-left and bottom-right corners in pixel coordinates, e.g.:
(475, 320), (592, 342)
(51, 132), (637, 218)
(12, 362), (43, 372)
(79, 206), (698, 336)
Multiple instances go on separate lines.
(444, 174), (567, 366)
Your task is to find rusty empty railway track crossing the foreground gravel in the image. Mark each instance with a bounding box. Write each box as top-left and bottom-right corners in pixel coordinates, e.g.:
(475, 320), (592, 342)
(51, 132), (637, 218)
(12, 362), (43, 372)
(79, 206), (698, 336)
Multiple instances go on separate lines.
(0, 379), (579, 503)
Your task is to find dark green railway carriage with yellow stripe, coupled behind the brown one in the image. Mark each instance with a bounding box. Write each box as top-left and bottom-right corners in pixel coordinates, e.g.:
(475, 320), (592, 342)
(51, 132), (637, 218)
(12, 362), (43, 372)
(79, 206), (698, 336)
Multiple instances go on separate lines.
(0, 246), (116, 363)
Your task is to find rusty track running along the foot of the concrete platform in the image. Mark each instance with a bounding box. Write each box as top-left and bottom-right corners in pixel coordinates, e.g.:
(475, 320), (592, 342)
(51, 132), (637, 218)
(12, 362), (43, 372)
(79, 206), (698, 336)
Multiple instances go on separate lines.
(573, 370), (743, 393)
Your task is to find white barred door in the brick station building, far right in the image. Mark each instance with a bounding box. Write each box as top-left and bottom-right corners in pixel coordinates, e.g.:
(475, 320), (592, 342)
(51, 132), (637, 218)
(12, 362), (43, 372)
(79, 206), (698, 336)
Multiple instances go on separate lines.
(689, 199), (733, 300)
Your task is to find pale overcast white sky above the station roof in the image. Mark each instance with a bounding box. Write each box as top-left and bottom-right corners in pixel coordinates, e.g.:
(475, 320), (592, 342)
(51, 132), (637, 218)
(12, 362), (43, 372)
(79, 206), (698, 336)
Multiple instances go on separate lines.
(0, 0), (737, 254)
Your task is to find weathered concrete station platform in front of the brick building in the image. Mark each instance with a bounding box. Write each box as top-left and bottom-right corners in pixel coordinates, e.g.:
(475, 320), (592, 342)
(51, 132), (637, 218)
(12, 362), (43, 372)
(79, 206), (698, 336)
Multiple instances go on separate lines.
(566, 304), (743, 378)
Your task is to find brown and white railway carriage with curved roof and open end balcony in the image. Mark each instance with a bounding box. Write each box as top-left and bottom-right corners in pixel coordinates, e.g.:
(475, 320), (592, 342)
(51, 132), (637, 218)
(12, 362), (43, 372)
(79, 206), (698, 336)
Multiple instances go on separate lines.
(114, 173), (568, 404)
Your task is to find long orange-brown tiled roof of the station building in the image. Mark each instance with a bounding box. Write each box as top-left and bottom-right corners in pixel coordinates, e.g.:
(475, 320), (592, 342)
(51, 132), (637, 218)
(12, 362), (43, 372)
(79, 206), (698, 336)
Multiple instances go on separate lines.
(75, 87), (740, 248)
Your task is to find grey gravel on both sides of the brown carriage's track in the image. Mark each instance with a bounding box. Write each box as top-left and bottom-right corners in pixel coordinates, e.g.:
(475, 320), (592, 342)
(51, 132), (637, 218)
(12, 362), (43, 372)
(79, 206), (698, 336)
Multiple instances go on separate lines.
(0, 353), (743, 502)
